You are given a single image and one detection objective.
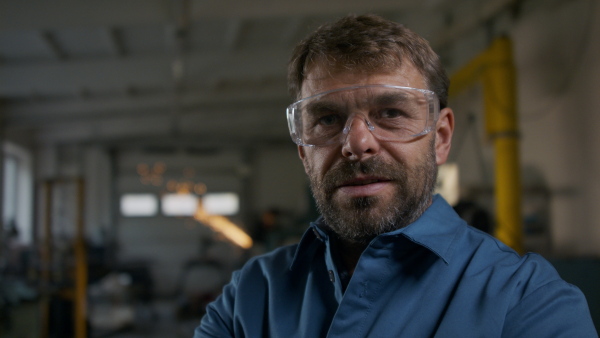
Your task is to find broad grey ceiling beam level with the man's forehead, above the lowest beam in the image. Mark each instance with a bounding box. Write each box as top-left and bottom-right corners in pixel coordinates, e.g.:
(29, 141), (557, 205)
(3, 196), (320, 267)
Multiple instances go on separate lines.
(0, 49), (289, 99)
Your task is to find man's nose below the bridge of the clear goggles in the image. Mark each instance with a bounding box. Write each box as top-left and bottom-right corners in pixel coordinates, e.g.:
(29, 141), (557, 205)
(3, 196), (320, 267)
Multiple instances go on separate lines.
(342, 117), (379, 161)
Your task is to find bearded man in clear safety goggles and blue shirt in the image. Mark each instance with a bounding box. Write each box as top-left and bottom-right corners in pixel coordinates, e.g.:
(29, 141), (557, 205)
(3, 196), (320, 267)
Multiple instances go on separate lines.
(195, 16), (597, 337)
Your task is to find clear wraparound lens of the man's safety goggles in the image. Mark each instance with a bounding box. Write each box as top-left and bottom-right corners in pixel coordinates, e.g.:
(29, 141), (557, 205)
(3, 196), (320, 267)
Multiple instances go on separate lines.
(287, 85), (439, 146)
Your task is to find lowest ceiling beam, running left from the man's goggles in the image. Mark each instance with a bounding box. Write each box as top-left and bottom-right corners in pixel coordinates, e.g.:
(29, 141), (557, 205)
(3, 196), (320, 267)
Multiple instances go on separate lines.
(5, 104), (291, 145)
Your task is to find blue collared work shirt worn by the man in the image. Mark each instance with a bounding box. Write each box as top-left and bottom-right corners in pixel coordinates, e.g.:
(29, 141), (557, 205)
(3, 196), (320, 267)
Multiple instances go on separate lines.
(194, 196), (598, 338)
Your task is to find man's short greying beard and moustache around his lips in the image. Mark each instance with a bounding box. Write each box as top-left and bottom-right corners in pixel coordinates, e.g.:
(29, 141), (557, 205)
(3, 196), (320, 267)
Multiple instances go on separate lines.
(307, 139), (437, 245)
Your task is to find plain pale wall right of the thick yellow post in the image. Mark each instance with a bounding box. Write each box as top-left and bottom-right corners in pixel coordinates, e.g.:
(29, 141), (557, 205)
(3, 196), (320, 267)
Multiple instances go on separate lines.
(512, 0), (600, 255)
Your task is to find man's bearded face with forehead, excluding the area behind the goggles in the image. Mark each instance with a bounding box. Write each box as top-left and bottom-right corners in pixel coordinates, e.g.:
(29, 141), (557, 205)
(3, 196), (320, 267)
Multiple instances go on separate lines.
(298, 64), (453, 244)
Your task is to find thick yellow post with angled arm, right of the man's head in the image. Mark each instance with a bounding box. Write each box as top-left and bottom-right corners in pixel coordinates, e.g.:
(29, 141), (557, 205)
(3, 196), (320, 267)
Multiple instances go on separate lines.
(450, 38), (523, 253)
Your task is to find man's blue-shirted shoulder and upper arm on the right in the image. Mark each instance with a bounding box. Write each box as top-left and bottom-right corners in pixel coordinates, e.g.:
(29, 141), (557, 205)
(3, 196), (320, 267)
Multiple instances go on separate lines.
(450, 227), (593, 337)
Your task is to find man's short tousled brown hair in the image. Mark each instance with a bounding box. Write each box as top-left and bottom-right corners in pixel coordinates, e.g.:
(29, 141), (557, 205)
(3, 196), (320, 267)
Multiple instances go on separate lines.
(288, 15), (450, 107)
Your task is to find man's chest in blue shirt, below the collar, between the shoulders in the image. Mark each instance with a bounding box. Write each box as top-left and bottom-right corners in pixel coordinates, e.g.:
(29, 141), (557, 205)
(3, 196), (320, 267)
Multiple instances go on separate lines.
(246, 247), (507, 337)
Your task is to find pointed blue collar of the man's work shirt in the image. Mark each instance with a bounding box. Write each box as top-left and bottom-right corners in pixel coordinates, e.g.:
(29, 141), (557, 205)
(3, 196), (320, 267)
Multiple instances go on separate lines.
(290, 195), (464, 269)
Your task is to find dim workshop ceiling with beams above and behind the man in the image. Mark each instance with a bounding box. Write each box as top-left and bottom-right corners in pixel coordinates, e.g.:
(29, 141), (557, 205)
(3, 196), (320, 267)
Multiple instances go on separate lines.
(0, 0), (516, 146)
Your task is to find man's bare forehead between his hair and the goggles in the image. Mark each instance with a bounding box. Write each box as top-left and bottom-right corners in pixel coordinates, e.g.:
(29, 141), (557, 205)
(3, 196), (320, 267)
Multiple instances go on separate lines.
(301, 62), (428, 98)
